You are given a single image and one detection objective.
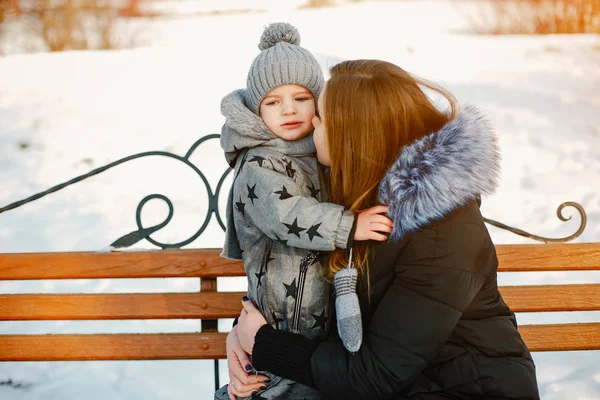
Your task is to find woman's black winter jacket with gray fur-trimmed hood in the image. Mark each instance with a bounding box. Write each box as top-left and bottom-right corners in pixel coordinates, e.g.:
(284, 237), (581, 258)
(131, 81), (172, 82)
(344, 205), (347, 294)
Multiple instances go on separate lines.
(252, 108), (539, 400)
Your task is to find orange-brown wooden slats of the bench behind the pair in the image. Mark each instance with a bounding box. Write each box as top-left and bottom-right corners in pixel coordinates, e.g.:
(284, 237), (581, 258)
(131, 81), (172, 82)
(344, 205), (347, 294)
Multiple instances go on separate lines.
(0, 243), (600, 386)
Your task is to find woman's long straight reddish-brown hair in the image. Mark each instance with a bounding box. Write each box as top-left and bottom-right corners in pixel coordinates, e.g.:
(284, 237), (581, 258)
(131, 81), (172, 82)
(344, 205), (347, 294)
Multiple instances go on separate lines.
(322, 60), (456, 277)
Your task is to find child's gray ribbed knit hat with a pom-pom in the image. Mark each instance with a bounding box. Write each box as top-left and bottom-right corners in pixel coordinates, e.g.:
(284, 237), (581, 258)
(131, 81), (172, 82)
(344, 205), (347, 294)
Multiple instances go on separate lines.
(245, 22), (325, 114)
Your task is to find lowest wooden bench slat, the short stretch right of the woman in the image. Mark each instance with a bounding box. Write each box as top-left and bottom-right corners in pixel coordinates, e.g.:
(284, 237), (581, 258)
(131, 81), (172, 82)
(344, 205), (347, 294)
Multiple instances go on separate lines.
(519, 322), (600, 351)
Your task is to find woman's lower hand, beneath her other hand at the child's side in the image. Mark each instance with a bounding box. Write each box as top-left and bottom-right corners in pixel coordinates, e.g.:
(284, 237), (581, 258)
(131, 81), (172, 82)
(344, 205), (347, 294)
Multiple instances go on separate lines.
(226, 325), (269, 400)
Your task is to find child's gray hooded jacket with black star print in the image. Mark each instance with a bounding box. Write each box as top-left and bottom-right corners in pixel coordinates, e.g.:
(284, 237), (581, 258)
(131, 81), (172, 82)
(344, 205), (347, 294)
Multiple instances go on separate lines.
(221, 90), (354, 337)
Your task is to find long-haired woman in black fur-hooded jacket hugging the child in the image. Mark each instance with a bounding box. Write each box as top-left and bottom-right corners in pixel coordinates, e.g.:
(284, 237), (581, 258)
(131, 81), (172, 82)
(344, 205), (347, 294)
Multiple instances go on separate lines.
(228, 60), (539, 400)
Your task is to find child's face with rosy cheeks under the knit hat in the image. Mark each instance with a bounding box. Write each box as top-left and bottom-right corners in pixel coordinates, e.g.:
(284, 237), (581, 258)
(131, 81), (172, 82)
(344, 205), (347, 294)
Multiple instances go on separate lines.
(259, 85), (315, 140)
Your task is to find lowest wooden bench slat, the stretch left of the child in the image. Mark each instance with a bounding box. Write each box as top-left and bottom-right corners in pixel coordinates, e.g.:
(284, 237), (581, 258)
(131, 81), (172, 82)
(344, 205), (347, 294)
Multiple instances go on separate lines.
(0, 332), (227, 361)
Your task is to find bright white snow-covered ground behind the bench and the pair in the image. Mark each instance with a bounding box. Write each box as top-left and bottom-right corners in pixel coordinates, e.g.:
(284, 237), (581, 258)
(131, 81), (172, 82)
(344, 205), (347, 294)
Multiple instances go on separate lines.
(0, 0), (600, 400)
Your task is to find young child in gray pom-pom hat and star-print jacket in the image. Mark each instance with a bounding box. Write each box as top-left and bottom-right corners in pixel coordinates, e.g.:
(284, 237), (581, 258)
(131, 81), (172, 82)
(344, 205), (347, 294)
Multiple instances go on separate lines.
(215, 23), (392, 400)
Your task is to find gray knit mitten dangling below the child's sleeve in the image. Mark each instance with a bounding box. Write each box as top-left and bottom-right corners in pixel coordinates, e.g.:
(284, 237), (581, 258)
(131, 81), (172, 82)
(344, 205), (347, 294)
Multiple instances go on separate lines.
(333, 249), (362, 353)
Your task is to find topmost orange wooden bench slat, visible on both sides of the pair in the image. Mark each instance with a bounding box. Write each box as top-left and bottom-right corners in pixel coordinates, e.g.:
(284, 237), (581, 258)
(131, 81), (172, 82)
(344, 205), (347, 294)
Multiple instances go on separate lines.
(0, 243), (600, 280)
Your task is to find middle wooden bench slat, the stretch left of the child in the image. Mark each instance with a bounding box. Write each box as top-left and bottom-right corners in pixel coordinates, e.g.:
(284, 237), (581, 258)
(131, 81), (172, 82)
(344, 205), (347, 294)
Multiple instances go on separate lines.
(0, 292), (246, 321)
